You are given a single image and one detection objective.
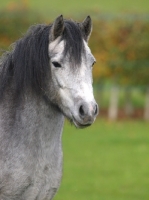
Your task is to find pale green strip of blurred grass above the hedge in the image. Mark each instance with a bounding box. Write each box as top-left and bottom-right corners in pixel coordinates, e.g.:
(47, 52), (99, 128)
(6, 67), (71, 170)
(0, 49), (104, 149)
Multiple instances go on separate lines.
(0, 0), (149, 17)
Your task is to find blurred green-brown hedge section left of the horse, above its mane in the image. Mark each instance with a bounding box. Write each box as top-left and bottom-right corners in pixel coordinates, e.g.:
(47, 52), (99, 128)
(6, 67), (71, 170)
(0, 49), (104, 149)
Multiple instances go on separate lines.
(0, 8), (42, 54)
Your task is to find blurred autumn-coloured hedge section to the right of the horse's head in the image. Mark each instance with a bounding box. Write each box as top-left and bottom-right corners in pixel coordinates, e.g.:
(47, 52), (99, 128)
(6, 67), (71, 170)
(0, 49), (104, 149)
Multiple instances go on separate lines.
(90, 15), (149, 85)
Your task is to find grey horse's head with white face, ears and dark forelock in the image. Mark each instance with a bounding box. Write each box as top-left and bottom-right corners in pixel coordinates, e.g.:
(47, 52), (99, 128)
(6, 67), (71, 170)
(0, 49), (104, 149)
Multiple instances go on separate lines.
(47, 15), (98, 128)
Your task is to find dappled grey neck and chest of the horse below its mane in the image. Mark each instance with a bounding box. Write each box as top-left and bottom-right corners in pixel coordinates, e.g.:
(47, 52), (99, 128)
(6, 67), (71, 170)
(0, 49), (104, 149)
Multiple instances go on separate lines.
(0, 95), (64, 199)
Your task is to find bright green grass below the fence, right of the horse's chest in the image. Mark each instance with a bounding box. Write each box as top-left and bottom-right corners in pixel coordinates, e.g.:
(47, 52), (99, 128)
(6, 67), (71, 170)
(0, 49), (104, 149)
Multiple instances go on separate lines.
(54, 120), (149, 200)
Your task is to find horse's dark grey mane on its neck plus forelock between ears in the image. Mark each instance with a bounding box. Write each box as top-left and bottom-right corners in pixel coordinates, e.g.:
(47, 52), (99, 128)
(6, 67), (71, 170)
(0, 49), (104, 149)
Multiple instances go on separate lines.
(0, 20), (84, 99)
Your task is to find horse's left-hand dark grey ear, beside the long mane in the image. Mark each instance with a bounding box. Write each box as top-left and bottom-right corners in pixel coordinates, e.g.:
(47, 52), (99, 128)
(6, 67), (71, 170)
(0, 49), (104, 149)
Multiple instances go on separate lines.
(51, 15), (64, 41)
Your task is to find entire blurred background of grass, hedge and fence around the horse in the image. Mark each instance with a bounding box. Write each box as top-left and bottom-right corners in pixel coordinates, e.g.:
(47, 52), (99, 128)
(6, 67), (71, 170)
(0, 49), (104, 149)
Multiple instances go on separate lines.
(0, 0), (149, 200)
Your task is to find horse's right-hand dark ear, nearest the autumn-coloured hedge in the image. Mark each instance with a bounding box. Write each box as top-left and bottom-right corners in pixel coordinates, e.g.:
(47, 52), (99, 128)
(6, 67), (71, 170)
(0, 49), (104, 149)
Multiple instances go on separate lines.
(80, 16), (92, 42)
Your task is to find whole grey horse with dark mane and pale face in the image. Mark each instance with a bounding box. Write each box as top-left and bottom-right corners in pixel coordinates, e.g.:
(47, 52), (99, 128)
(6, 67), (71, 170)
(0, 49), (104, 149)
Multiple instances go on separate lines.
(0, 15), (98, 200)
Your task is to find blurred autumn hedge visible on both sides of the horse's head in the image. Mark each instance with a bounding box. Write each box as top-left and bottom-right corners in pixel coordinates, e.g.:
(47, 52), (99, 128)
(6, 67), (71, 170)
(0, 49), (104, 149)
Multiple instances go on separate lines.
(0, 9), (149, 86)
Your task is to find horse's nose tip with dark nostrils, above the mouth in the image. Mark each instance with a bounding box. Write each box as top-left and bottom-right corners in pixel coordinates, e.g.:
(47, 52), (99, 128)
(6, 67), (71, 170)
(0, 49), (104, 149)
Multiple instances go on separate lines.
(79, 102), (98, 123)
